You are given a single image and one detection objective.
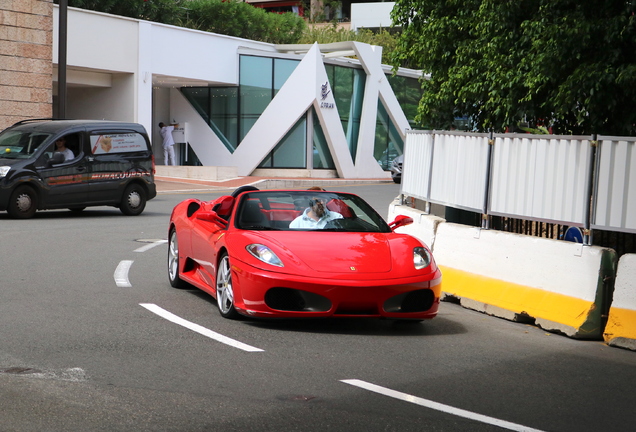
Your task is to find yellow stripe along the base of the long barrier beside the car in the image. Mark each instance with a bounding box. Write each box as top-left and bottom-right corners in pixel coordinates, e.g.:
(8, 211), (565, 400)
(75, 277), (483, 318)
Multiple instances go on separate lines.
(439, 266), (596, 329)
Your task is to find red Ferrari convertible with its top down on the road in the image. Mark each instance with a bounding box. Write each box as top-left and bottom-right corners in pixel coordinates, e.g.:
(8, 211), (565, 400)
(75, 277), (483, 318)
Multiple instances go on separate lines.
(168, 186), (441, 320)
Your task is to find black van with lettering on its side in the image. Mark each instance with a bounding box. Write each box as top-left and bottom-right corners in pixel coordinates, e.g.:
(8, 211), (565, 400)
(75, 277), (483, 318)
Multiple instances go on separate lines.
(0, 120), (157, 219)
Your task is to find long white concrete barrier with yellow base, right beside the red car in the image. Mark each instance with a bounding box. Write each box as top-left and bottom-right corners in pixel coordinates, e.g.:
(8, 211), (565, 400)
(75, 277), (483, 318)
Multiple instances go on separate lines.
(389, 205), (616, 340)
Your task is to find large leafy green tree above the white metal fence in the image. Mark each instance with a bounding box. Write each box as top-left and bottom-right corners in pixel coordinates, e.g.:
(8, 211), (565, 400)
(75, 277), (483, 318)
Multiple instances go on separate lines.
(392, 0), (636, 135)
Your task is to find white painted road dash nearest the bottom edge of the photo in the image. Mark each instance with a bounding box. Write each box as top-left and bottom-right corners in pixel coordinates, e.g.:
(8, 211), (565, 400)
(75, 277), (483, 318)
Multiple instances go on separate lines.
(340, 379), (542, 432)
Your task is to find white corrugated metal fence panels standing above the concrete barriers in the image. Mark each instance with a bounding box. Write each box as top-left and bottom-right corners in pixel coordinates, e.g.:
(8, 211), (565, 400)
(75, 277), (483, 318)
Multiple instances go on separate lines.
(401, 131), (636, 232)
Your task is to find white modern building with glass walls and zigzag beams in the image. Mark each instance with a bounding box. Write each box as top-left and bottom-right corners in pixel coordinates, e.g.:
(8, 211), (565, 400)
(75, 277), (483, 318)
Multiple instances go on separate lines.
(53, 7), (420, 178)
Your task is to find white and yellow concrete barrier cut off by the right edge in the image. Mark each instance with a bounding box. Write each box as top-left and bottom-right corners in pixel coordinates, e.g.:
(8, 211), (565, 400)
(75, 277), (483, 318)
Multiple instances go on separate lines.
(603, 254), (636, 350)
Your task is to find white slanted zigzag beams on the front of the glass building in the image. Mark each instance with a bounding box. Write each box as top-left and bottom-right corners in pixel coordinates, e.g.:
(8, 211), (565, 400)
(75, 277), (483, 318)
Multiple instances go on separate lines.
(184, 42), (409, 178)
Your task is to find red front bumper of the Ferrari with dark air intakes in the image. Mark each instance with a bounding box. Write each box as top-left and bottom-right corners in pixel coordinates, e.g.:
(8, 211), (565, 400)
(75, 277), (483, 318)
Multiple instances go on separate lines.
(232, 260), (442, 320)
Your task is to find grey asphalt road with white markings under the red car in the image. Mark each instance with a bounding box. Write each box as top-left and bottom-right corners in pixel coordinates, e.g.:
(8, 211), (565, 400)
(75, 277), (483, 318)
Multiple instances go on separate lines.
(0, 184), (636, 432)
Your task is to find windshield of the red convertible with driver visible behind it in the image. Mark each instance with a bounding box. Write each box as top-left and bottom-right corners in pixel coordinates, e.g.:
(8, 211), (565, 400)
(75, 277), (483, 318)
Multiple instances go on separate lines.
(235, 191), (391, 233)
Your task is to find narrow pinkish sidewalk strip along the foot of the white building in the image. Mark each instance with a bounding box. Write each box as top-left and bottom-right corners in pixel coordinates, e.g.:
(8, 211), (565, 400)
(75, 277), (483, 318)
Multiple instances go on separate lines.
(155, 176), (393, 194)
